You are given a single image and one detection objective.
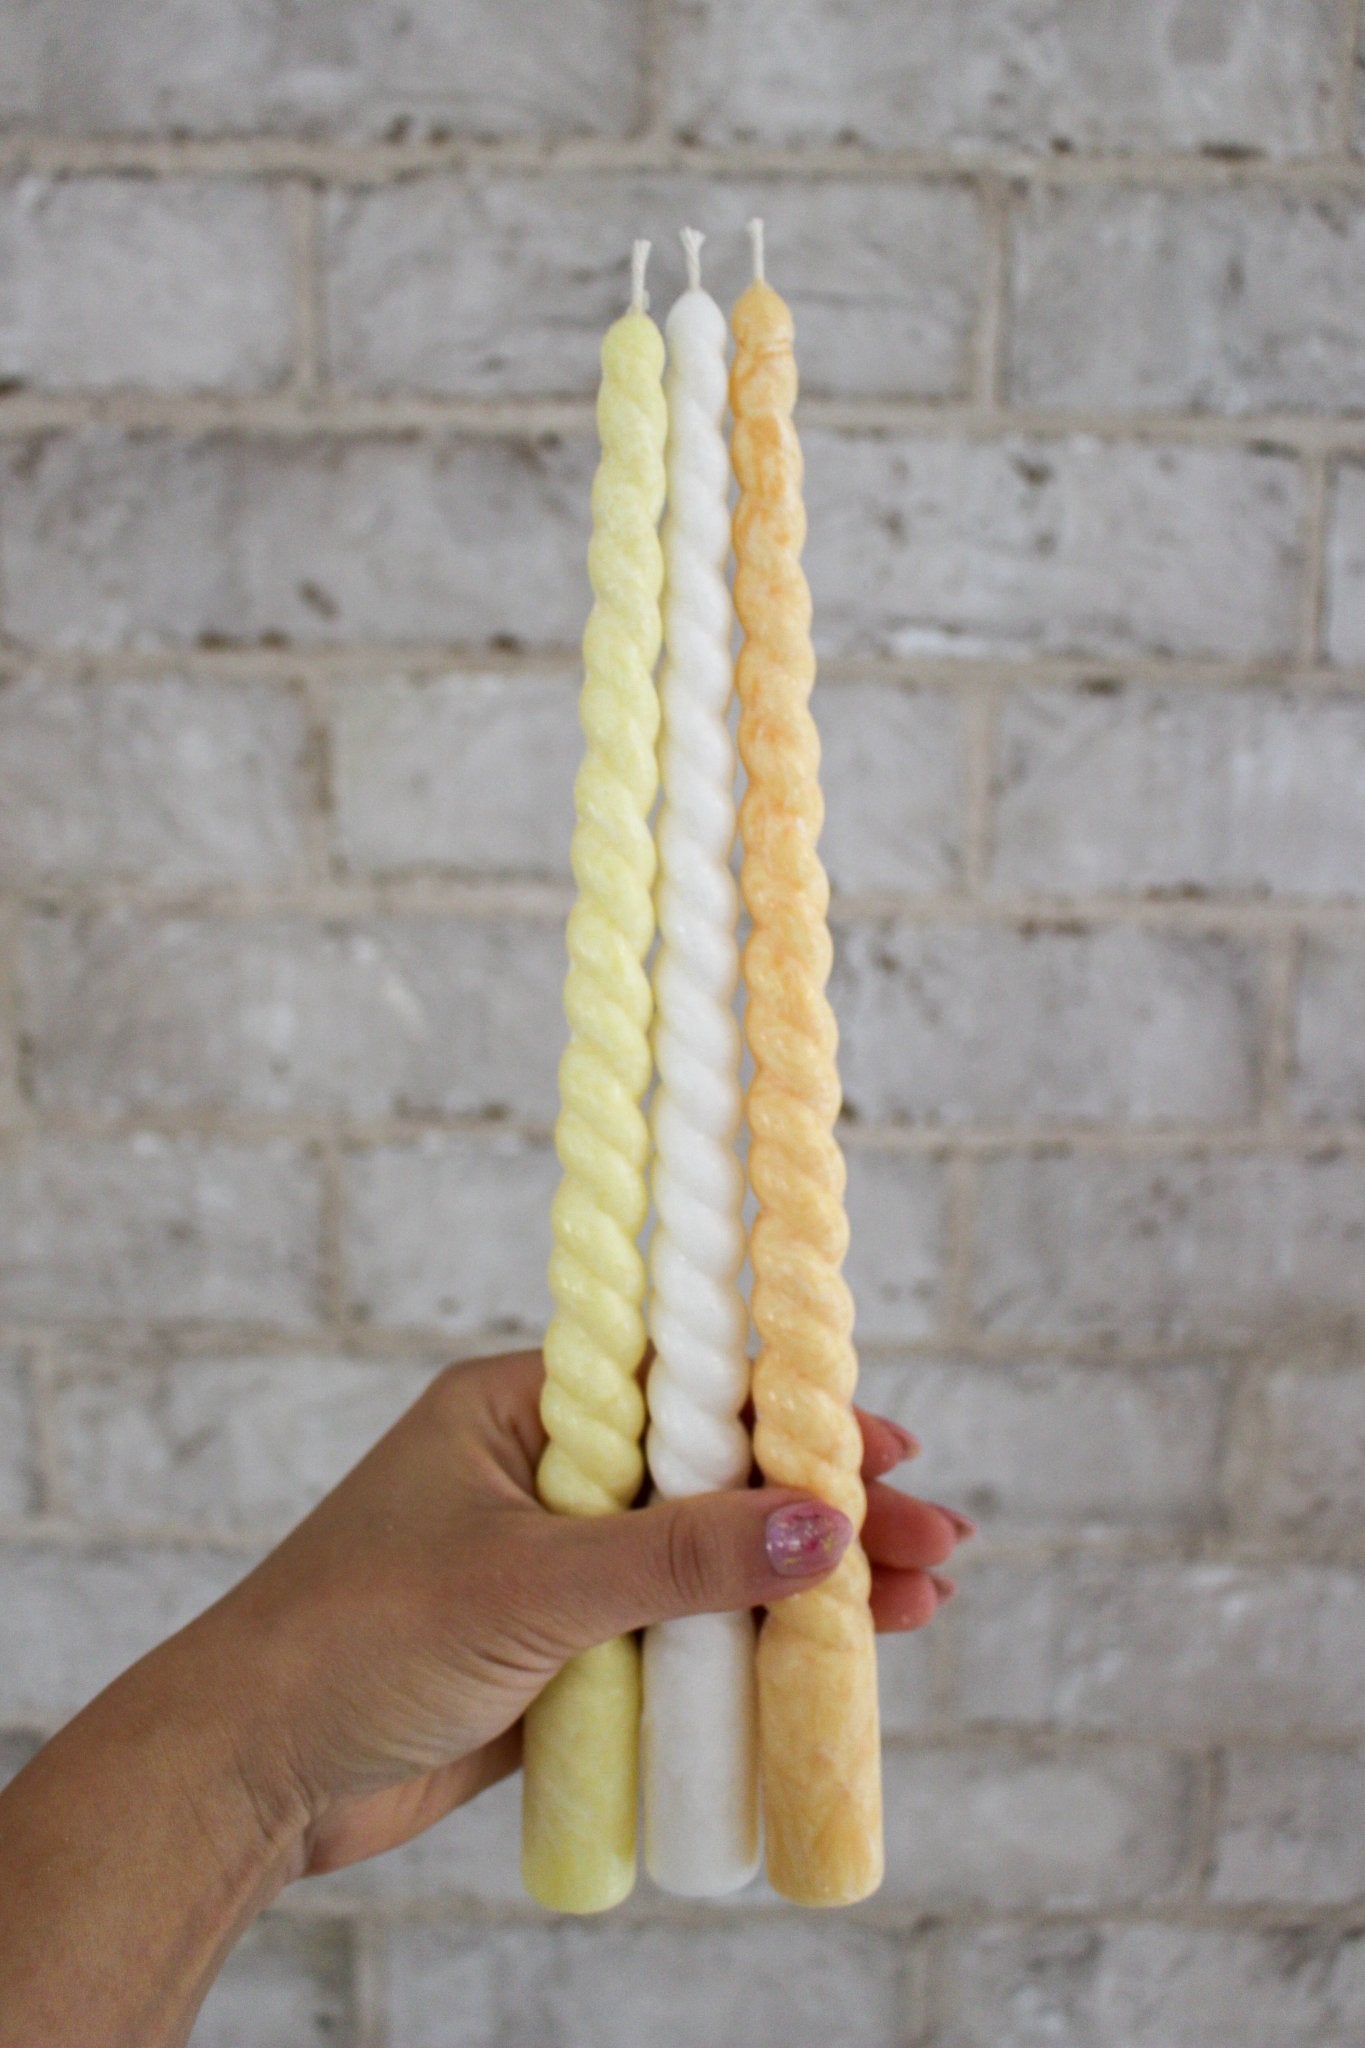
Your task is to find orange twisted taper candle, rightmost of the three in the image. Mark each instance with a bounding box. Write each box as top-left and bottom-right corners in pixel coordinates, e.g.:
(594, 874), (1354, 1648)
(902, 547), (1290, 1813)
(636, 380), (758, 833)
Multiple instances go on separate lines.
(731, 221), (882, 1907)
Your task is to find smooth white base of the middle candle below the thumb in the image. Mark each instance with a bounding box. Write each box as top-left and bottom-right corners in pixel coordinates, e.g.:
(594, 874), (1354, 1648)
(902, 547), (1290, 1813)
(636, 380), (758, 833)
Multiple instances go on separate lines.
(641, 1614), (759, 1898)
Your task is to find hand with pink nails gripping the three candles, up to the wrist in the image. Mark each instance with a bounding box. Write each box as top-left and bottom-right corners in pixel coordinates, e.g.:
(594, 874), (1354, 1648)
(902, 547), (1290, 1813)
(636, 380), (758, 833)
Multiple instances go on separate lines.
(213, 1352), (972, 1874)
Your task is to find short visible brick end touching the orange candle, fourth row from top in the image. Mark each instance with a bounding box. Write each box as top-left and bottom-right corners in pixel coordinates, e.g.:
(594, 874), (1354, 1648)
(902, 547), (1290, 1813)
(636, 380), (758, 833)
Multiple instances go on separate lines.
(814, 682), (966, 891)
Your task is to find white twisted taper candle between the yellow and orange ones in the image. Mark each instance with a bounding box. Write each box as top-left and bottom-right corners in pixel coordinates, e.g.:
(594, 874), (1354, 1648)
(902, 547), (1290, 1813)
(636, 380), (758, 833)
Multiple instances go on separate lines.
(641, 227), (759, 1898)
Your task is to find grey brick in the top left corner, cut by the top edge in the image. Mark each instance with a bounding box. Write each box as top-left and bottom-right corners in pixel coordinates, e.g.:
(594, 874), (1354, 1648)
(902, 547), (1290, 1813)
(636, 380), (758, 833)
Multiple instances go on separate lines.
(0, 0), (643, 139)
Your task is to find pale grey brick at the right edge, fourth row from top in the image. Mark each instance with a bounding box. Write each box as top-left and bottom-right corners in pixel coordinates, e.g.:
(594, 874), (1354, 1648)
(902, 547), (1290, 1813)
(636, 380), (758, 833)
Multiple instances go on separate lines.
(993, 682), (1365, 899)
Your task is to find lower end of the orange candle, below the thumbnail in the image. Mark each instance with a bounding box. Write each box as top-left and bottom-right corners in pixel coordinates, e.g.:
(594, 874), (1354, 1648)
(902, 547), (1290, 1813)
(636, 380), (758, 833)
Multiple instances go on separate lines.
(757, 1567), (884, 1907)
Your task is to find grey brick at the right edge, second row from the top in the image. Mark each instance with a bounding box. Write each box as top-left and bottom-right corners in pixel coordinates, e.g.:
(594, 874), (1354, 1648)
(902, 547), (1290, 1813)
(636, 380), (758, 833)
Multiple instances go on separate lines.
(1007, 186), (1365, 412)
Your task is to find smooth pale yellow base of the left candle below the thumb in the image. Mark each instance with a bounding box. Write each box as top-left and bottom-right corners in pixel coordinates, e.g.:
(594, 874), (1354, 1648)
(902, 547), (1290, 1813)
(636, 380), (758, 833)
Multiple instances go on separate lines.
(522, 1636), (641, 1913)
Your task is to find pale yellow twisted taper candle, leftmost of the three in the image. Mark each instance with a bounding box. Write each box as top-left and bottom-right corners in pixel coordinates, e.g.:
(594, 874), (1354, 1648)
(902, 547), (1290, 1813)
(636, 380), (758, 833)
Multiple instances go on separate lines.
(522, 242), (665, 1913)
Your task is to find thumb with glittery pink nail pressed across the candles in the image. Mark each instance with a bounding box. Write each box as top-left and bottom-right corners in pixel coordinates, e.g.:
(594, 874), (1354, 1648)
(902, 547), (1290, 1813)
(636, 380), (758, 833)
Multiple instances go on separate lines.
(536, 1487), (853, 1653)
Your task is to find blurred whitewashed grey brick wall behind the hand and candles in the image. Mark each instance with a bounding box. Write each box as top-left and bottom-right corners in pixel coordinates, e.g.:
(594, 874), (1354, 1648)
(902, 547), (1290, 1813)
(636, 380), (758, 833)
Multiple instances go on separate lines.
(0, 0), (1365, 2048)
